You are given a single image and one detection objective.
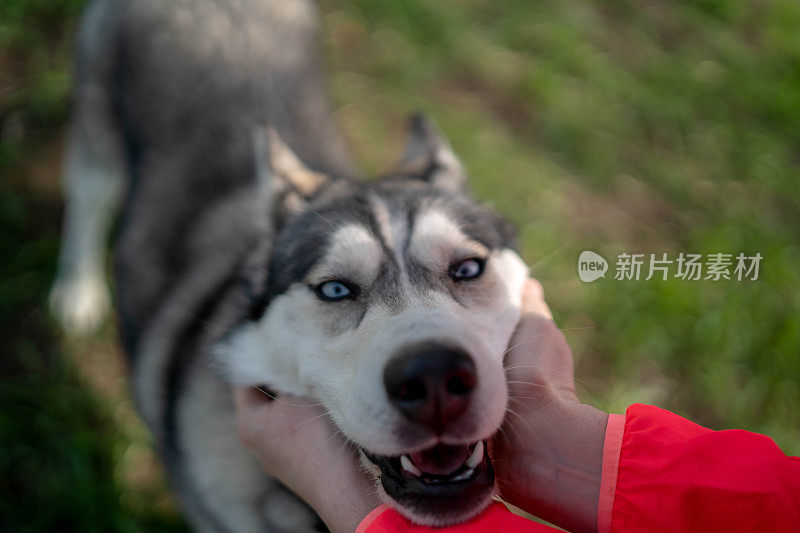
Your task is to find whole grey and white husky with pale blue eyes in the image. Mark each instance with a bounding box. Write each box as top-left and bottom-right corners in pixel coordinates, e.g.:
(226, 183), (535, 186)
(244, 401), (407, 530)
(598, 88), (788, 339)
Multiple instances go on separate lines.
(51, 0), (527, 531)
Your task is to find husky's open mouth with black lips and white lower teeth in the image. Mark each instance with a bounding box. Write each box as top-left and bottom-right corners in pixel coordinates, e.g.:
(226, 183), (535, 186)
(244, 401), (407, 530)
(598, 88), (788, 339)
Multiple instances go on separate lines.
(362, 441), (494, 515)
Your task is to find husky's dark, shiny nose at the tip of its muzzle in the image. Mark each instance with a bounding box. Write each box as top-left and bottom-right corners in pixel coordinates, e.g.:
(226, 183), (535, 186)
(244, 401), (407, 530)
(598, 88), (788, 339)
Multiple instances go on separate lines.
(383, 343), (478, 435)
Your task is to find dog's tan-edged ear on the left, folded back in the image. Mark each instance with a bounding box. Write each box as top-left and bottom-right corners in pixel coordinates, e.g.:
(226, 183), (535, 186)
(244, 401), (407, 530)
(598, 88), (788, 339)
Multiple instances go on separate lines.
(253, 126), (330, 218)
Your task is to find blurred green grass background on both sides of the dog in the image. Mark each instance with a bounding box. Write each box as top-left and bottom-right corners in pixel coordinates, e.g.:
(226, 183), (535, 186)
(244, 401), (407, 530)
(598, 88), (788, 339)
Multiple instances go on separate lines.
(0, 0), (800, 531)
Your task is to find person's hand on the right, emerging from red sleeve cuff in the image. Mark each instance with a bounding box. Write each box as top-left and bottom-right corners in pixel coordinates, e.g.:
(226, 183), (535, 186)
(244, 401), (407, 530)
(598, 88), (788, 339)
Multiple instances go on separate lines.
(490, 280), (608, 533)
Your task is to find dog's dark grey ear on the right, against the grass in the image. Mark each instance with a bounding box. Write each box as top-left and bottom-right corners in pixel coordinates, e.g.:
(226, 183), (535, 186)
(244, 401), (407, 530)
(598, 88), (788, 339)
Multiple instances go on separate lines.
(396, 113), (467, 192)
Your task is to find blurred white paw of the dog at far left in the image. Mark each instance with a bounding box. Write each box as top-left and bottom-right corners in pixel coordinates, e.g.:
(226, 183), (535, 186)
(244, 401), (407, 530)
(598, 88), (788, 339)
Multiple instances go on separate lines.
(50, 275), (111, 335)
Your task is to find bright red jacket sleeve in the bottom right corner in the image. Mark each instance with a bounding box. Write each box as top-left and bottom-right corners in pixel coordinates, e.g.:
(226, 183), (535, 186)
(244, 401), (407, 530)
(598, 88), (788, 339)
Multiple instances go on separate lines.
(598, 404), (800, 533)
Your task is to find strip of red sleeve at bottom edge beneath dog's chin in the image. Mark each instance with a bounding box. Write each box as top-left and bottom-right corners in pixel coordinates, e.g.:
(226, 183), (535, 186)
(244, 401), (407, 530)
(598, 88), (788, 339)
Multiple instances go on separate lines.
(356, 503), (561, 533)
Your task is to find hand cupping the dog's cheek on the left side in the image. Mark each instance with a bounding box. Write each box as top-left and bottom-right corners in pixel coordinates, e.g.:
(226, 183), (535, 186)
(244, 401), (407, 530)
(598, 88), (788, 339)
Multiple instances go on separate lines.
(234, 388), (380, 532)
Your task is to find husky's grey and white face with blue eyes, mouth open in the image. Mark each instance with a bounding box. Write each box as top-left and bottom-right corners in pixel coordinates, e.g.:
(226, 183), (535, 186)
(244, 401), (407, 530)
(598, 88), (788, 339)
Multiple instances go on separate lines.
(218, 116), (527, 525)
